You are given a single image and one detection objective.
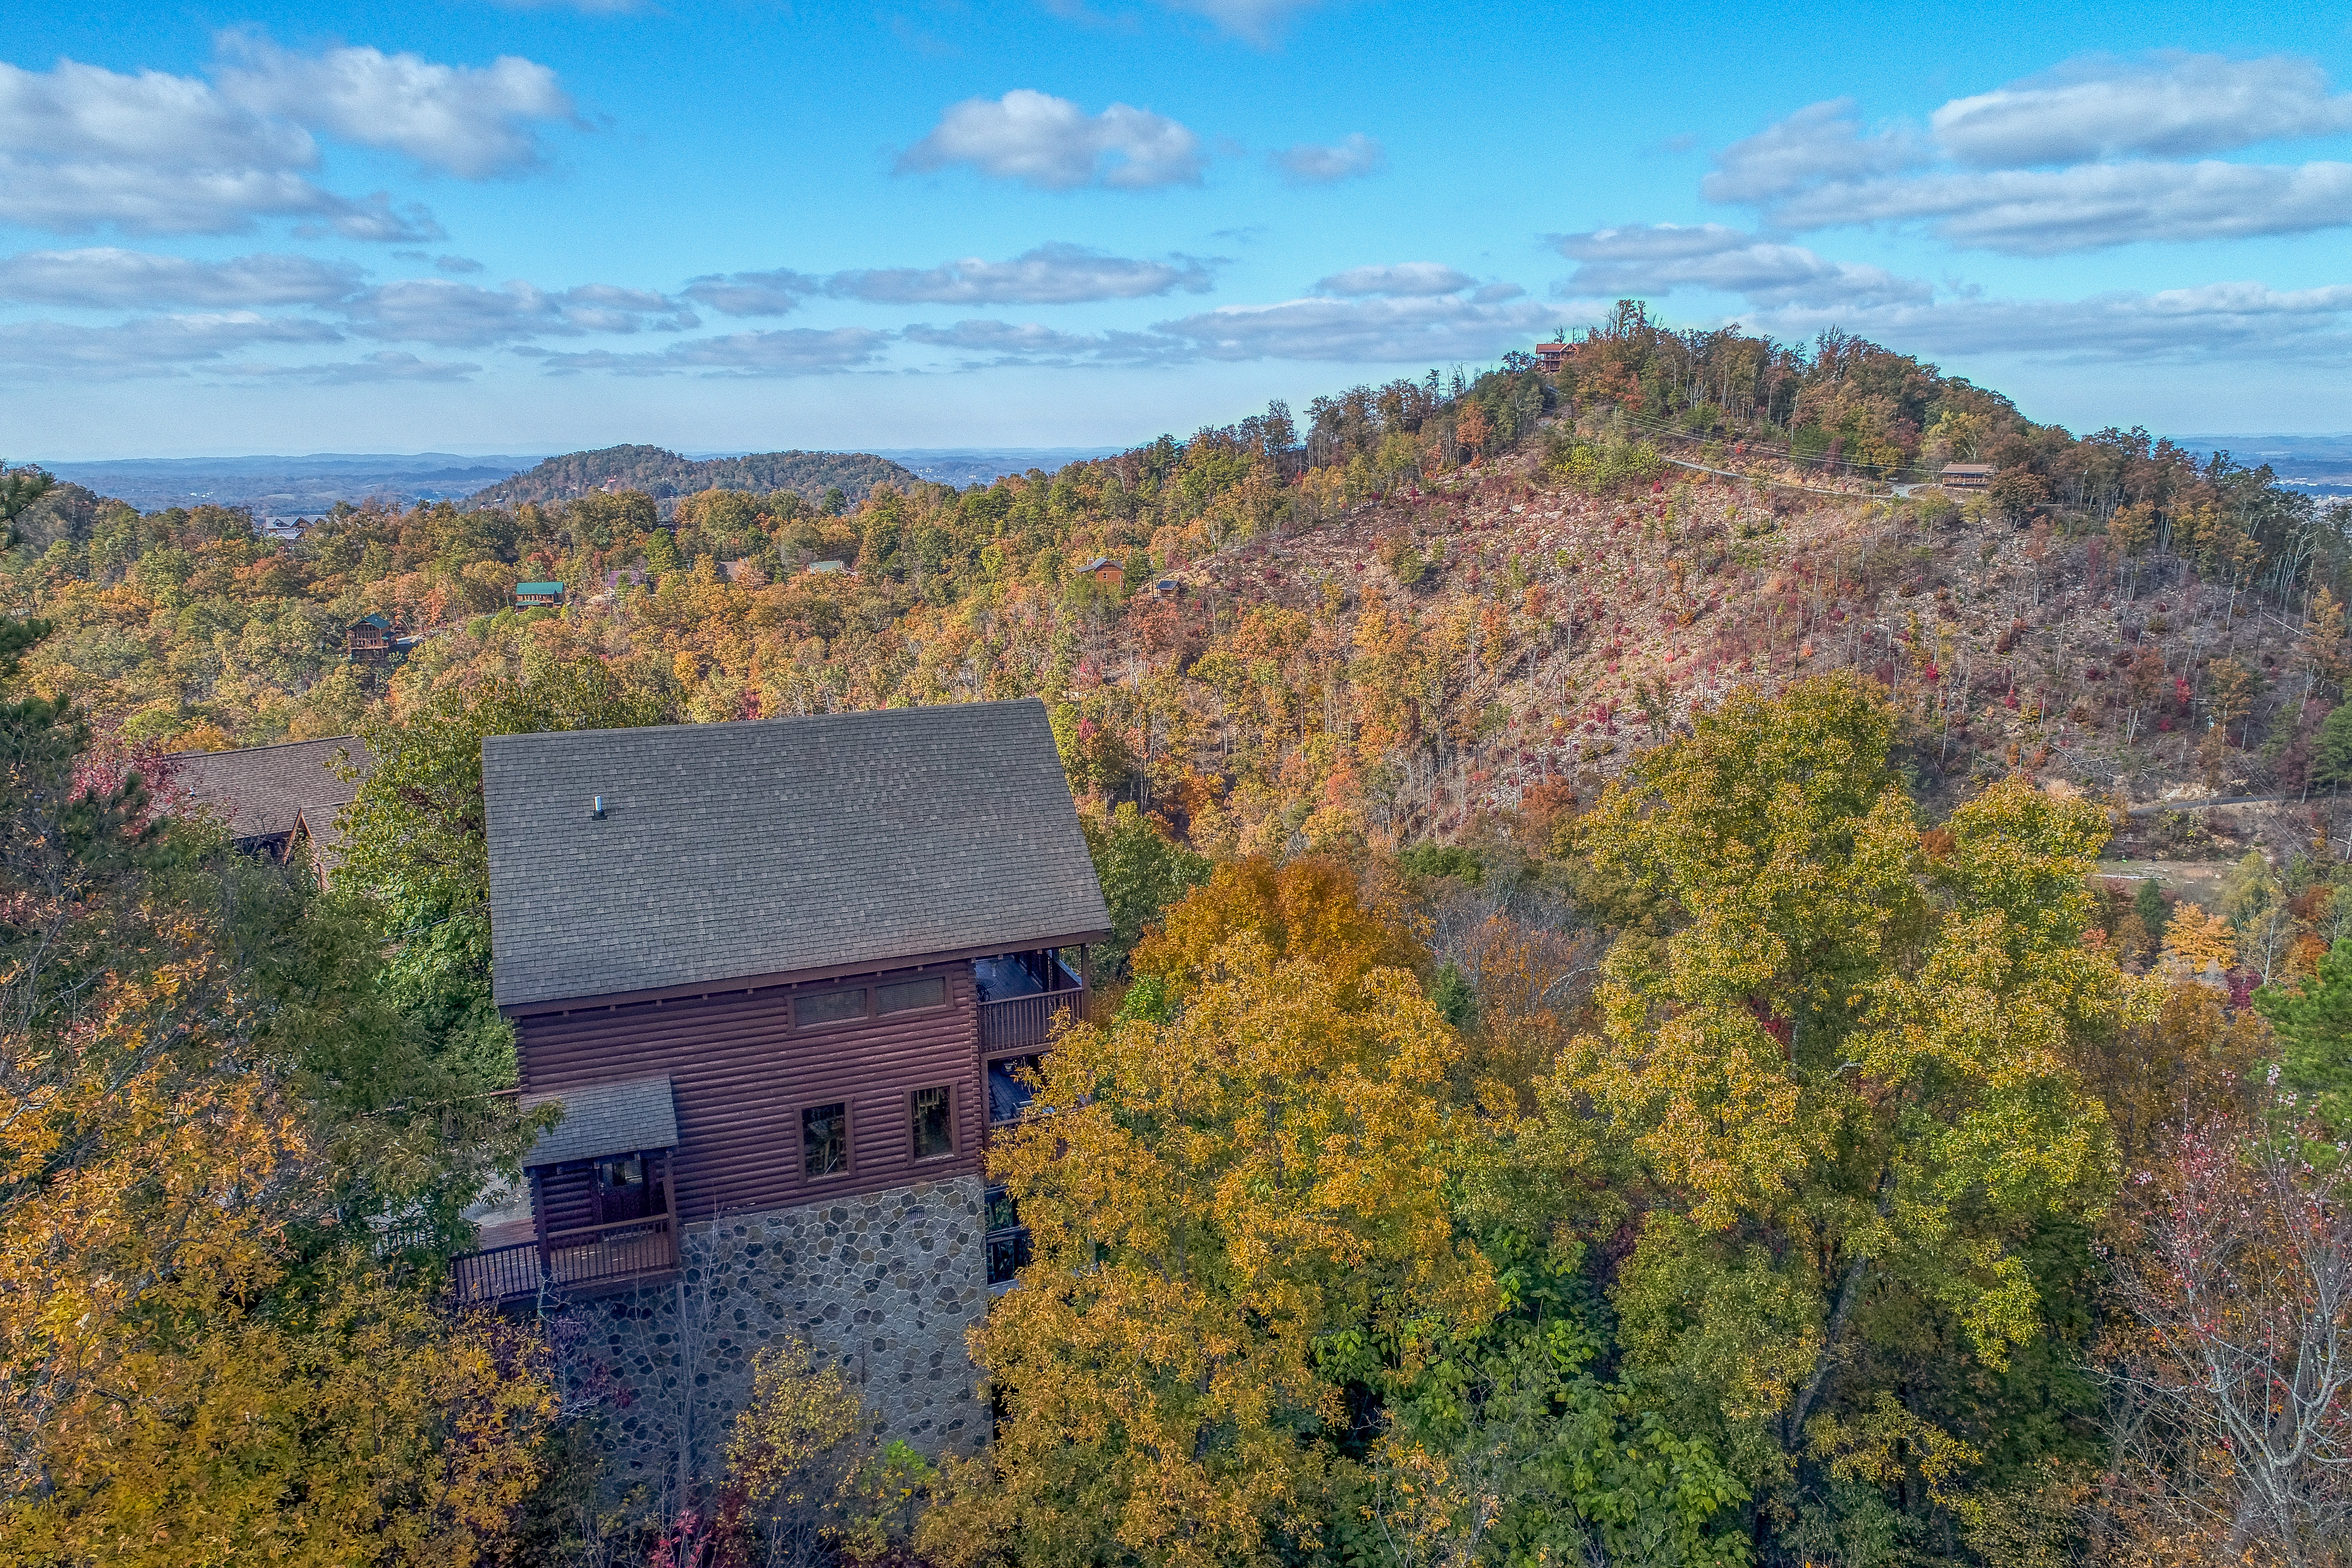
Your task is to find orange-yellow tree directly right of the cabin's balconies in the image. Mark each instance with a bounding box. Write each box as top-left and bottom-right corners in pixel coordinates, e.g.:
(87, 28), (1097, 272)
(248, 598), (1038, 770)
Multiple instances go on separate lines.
(917, 863), (1494, 1566)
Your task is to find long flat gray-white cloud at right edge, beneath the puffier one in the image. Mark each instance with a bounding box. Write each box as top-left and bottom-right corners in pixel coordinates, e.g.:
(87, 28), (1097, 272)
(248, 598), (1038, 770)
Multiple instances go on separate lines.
(1769, 160), (2352, 256)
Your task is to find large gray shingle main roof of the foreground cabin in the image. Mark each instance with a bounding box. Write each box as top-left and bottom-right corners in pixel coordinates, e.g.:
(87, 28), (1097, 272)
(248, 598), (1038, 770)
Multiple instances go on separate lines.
(482, 698), (1110, 1006)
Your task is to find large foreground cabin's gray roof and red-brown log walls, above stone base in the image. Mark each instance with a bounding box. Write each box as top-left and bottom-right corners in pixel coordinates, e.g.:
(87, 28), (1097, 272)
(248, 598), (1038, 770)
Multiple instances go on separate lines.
(456, 701), (1110, 1300)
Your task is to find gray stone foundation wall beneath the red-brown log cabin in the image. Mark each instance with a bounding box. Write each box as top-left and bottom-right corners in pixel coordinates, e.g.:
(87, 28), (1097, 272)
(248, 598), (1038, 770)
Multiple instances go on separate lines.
(555, 1178), (988, 1493)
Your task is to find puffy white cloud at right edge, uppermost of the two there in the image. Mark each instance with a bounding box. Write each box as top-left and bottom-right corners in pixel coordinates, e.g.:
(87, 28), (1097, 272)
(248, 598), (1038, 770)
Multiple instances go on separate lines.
(1929, 54), (2352, 169)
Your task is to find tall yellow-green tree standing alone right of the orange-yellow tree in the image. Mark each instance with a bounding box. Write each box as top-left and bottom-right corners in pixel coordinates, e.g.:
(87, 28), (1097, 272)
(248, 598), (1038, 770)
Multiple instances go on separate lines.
(1550, 675), (2131, 1532)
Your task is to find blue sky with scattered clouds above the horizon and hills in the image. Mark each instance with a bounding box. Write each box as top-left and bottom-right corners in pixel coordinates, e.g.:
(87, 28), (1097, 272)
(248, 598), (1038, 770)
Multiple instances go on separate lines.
(0, 0), (2352, 461)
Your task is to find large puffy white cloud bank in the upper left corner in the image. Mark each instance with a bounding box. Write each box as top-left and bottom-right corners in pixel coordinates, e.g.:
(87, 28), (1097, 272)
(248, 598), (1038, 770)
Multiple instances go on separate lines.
(0, 35), (572, 245)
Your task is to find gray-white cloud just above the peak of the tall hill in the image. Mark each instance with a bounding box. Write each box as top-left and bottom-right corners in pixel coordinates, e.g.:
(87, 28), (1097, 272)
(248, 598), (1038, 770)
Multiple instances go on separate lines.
(1555, 224), (1931, 306)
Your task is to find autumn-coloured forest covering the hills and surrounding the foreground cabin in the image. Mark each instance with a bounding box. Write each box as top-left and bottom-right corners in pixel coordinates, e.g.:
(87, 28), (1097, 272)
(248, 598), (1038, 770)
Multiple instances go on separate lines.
(0, 308), (2352, 1568)
